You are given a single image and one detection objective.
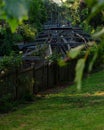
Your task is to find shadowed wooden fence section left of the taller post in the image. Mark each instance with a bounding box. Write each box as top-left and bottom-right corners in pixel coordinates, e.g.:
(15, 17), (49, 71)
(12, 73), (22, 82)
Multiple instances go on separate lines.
(0, 68), (33, 99)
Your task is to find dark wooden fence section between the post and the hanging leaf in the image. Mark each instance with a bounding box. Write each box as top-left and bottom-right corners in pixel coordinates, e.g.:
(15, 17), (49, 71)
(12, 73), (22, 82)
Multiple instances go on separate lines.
(33, 60), (76, 93)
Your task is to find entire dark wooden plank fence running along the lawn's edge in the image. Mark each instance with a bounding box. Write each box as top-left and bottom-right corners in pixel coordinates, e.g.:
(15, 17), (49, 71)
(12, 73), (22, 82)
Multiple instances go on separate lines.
(0, 60), (76, 99)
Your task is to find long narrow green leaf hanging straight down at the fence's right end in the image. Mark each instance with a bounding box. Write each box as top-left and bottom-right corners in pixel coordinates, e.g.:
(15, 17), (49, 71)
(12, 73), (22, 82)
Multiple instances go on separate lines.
(75, 58), (85, 90)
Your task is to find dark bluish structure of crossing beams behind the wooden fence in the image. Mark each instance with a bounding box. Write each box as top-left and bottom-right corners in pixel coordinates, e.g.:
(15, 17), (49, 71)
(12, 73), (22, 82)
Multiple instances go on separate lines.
(18, 23), (92, 61)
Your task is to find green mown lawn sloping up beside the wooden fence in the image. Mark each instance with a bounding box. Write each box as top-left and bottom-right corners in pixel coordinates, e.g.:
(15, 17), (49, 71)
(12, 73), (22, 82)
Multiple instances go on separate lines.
(0, 71), (104, 130)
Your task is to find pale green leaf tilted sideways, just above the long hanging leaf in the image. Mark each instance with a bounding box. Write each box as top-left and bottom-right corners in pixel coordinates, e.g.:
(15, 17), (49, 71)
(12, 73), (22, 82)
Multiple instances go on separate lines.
(68, 45), (84, 59)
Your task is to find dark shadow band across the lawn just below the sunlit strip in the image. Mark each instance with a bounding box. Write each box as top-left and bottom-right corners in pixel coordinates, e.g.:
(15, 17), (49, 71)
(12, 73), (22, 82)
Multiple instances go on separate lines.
(0, 95), (104, 115)
